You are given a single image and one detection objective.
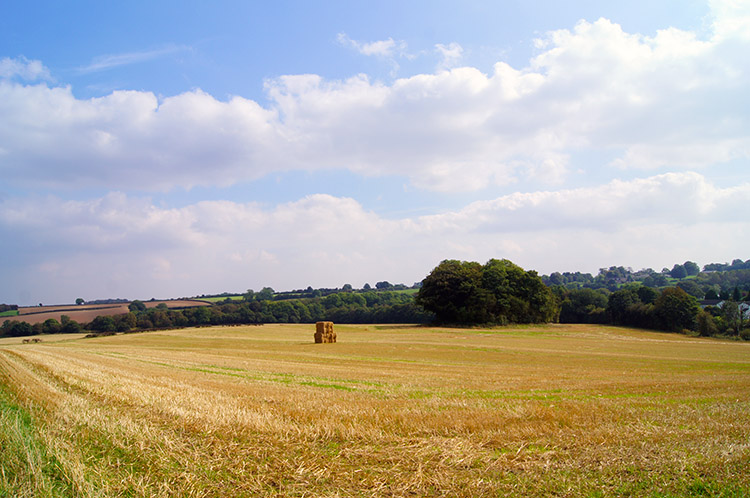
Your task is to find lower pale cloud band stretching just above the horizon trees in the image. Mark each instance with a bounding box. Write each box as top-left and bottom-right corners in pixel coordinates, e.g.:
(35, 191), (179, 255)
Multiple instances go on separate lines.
(0, 173), (750, 302)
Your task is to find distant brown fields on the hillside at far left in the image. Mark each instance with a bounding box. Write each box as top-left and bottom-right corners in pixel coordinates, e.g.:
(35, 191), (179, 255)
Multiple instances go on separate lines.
(16, 299), (211, 325)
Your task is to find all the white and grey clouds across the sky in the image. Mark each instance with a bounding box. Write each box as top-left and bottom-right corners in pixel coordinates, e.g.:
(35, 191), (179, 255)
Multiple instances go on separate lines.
(0, 2), (750, 304)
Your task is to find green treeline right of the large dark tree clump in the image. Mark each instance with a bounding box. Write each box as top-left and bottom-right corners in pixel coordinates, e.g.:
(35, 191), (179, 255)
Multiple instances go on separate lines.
(552, 284), (750, 339)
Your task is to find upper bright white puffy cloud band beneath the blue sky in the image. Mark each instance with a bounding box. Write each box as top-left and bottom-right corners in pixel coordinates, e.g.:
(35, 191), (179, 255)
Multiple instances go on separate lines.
(0, 1), (750, 195)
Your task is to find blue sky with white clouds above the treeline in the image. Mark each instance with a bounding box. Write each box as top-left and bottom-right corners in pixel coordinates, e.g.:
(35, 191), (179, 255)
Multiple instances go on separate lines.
(0, 0), (750, 305)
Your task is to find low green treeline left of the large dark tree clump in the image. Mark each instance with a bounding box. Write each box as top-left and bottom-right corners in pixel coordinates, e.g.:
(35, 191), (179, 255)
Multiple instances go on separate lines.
(0, 291), (434, 337)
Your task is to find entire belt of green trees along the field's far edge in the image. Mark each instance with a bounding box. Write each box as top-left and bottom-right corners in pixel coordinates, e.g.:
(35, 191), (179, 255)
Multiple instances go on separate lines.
(0, 259), (750, 336)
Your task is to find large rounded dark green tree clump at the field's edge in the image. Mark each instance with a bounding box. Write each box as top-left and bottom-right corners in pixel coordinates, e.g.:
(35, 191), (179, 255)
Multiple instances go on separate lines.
(415, 259), (558, 324)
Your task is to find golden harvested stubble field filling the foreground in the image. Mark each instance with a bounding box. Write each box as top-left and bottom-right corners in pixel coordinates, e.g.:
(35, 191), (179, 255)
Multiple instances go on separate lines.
(0, 325), (750, 497)
